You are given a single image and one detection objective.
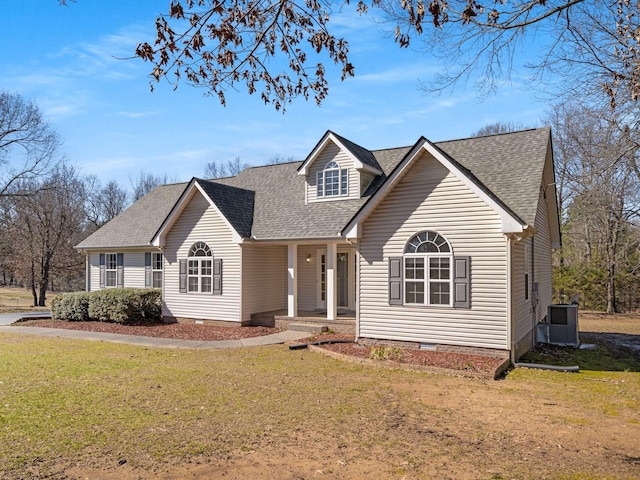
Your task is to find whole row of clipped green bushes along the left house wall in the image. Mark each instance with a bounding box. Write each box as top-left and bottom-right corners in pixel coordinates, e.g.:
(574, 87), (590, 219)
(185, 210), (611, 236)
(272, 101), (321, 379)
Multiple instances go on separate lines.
(51, 288), (162, 324)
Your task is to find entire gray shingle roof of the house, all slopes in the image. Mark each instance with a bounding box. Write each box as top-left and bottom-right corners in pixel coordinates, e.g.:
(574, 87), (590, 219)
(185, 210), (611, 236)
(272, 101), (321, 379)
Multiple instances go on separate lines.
(78, 128), (550, 248)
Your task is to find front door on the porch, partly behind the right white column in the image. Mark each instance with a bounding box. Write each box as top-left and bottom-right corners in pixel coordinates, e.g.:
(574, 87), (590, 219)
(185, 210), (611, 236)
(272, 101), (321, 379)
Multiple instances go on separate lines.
(317, 249), (356, 310)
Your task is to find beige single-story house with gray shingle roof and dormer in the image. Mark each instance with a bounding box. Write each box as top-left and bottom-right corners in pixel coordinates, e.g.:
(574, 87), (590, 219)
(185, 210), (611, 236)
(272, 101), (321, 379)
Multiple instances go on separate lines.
(77, 128), (560, 359)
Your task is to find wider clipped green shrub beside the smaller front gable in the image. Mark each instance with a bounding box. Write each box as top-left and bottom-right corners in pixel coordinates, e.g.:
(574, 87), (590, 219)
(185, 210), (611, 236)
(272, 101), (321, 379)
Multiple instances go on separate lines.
(89, 288), (162, 324)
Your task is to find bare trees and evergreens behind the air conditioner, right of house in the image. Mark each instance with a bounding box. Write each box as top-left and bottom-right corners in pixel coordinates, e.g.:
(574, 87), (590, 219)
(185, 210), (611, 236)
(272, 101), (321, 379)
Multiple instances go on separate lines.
(547, 102), (640, 313)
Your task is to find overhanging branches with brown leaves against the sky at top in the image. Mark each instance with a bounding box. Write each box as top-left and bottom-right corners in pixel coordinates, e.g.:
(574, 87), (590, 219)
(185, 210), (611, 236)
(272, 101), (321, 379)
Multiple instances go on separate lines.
(129, 0), (640, 109)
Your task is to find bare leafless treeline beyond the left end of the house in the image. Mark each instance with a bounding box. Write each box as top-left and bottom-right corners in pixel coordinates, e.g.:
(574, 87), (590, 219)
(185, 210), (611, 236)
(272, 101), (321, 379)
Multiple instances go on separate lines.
(0, 91), (175, 306)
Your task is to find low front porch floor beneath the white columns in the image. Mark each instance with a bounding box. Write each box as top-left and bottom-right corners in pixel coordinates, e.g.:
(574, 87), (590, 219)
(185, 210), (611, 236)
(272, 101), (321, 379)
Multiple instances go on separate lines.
(251, 309), (356, 335)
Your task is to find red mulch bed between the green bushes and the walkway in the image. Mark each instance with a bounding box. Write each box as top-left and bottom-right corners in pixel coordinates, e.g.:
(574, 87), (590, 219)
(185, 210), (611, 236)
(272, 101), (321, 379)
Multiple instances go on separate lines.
(20, 320), (278, 341)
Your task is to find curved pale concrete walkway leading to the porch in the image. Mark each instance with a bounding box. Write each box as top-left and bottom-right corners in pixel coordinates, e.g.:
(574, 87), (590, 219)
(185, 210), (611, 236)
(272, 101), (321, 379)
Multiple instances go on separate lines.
(0, 312), (311, 349)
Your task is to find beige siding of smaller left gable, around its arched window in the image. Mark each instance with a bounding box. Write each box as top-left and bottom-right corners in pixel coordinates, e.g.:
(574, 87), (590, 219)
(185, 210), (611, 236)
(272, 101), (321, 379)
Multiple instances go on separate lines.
(163, 193), (241, 322)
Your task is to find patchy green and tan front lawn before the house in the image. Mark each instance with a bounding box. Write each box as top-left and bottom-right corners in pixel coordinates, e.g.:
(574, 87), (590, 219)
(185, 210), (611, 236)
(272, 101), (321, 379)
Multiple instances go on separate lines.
(0, 333), (640, 478)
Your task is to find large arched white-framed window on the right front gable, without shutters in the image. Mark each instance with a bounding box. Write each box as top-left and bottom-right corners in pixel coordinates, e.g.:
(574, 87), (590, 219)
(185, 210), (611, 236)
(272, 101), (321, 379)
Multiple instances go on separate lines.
(404, 231), (452, 306)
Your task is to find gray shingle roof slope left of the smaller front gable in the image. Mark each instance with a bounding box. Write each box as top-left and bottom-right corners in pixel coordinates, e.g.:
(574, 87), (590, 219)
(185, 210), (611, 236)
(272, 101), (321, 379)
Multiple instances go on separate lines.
(76, 183), (187, 249)
